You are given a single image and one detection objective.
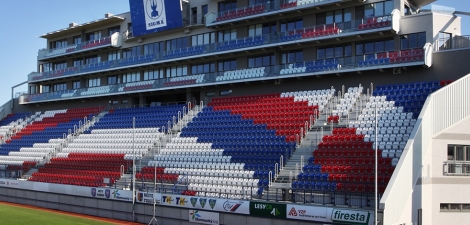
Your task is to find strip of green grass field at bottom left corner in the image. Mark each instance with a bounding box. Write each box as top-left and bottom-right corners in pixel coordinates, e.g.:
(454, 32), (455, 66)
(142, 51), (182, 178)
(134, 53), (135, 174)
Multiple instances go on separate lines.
(0, 204), (114, 225)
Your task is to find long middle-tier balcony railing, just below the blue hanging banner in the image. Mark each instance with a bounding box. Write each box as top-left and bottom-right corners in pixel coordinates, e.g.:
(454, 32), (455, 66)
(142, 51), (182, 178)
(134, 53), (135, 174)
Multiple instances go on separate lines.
(28, 16), (392, 82)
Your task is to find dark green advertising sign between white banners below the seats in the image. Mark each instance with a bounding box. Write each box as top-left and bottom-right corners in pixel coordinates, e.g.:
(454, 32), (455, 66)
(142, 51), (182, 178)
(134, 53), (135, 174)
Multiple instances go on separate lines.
(250, 202), (287, 219)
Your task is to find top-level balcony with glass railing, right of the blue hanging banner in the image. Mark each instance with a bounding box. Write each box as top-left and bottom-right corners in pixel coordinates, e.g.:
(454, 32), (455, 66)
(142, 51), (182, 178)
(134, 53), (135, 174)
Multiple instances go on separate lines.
(206, 0), (345, 27)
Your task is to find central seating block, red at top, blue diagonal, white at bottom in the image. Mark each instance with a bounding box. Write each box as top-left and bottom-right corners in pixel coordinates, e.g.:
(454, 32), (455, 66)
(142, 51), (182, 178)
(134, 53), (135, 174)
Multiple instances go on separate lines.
(143, 91), (330, 198)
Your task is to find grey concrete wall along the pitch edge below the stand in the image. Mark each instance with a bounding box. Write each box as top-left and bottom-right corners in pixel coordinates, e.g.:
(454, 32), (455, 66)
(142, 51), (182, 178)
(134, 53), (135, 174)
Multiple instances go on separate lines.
(0, 187), (321, 225)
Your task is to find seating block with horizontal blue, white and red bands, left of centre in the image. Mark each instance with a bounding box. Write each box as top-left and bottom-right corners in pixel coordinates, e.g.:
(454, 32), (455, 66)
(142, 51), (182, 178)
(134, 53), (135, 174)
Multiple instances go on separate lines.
(30, 105), (183, 187)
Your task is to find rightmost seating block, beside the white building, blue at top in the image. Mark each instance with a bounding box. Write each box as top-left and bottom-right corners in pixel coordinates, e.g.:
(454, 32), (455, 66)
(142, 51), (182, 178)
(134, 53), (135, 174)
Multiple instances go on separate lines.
(292, 82), (441, 193)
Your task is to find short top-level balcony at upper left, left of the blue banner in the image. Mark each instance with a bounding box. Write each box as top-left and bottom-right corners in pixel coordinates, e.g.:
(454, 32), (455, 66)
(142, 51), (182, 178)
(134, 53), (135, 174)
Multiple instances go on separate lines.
(38, 33), (122, 60)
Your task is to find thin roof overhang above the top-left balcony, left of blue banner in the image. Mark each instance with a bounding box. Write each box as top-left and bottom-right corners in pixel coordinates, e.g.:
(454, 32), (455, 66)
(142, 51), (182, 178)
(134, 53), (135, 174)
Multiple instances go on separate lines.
(39, 16), (126, 39)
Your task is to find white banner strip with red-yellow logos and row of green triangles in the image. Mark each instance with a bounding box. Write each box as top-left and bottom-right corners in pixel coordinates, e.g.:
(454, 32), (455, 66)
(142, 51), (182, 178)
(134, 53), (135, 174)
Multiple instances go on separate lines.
(161, 194), (250, 214)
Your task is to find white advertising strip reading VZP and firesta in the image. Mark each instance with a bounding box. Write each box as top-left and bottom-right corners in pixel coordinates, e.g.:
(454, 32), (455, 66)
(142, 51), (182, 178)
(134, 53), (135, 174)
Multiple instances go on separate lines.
(287, 204), (373, 225)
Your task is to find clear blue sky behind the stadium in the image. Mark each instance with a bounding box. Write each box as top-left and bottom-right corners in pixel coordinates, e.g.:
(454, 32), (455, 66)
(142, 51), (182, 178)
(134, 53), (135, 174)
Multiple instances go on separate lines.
(0, 0), (470, 109)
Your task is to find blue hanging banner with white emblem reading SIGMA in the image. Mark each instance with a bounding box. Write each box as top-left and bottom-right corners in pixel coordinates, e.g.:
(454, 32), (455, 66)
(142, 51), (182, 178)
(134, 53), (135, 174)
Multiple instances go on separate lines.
(129, 0), (183, 37)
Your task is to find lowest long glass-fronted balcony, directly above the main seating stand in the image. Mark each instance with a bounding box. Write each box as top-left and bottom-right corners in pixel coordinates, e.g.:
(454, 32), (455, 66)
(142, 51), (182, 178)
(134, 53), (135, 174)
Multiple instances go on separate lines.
(20, 44), (431, 104)
